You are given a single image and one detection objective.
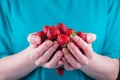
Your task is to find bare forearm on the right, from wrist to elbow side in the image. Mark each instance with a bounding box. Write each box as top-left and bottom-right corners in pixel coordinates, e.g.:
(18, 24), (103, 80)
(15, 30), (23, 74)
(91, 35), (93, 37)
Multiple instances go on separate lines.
(81, 54), (119, 80)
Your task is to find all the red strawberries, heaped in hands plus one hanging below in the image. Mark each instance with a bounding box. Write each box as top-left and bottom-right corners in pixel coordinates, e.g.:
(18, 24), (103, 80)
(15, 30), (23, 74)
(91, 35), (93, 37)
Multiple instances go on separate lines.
(36, 23), (85, 75)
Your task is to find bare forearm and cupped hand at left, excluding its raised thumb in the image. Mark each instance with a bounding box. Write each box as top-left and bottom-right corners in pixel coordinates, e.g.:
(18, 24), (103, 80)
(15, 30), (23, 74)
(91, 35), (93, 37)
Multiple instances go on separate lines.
(0, 36), (63, 80)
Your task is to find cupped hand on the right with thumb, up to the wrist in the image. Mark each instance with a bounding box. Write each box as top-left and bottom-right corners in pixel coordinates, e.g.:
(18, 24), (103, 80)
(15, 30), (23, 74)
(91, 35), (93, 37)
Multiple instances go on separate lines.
(62, 33), (96, 70)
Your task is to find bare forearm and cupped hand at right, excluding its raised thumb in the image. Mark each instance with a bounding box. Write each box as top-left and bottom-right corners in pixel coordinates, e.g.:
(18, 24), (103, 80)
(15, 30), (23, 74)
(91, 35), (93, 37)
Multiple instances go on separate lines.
(62, 36), (119, 80)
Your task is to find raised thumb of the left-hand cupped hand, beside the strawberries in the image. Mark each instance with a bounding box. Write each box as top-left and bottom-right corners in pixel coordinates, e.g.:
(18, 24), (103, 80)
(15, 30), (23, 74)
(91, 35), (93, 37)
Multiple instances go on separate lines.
(27, 33), (42, 47)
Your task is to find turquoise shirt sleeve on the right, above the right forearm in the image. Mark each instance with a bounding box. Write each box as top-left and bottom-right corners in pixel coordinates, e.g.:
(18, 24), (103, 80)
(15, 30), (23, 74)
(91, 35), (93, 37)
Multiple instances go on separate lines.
(102, 0), (120, 58)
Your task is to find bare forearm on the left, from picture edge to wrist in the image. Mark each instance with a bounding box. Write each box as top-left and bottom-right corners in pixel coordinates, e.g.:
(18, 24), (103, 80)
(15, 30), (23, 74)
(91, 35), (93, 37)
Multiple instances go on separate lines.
(0, 47), (36, 80)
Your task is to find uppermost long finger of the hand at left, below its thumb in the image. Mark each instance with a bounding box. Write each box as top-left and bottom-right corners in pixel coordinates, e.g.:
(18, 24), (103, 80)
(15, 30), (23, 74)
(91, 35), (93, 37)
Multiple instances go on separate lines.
(31, 40), (53, 60)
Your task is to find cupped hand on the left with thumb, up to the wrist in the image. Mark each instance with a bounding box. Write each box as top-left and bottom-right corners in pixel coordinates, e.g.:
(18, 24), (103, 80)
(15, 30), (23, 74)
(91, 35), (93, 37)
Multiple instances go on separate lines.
(28, 33), (63, 68)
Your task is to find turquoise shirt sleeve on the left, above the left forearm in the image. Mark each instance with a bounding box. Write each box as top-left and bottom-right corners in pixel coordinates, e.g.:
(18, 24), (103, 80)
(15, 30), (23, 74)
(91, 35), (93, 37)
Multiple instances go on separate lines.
(0, 0), (13, 58)
